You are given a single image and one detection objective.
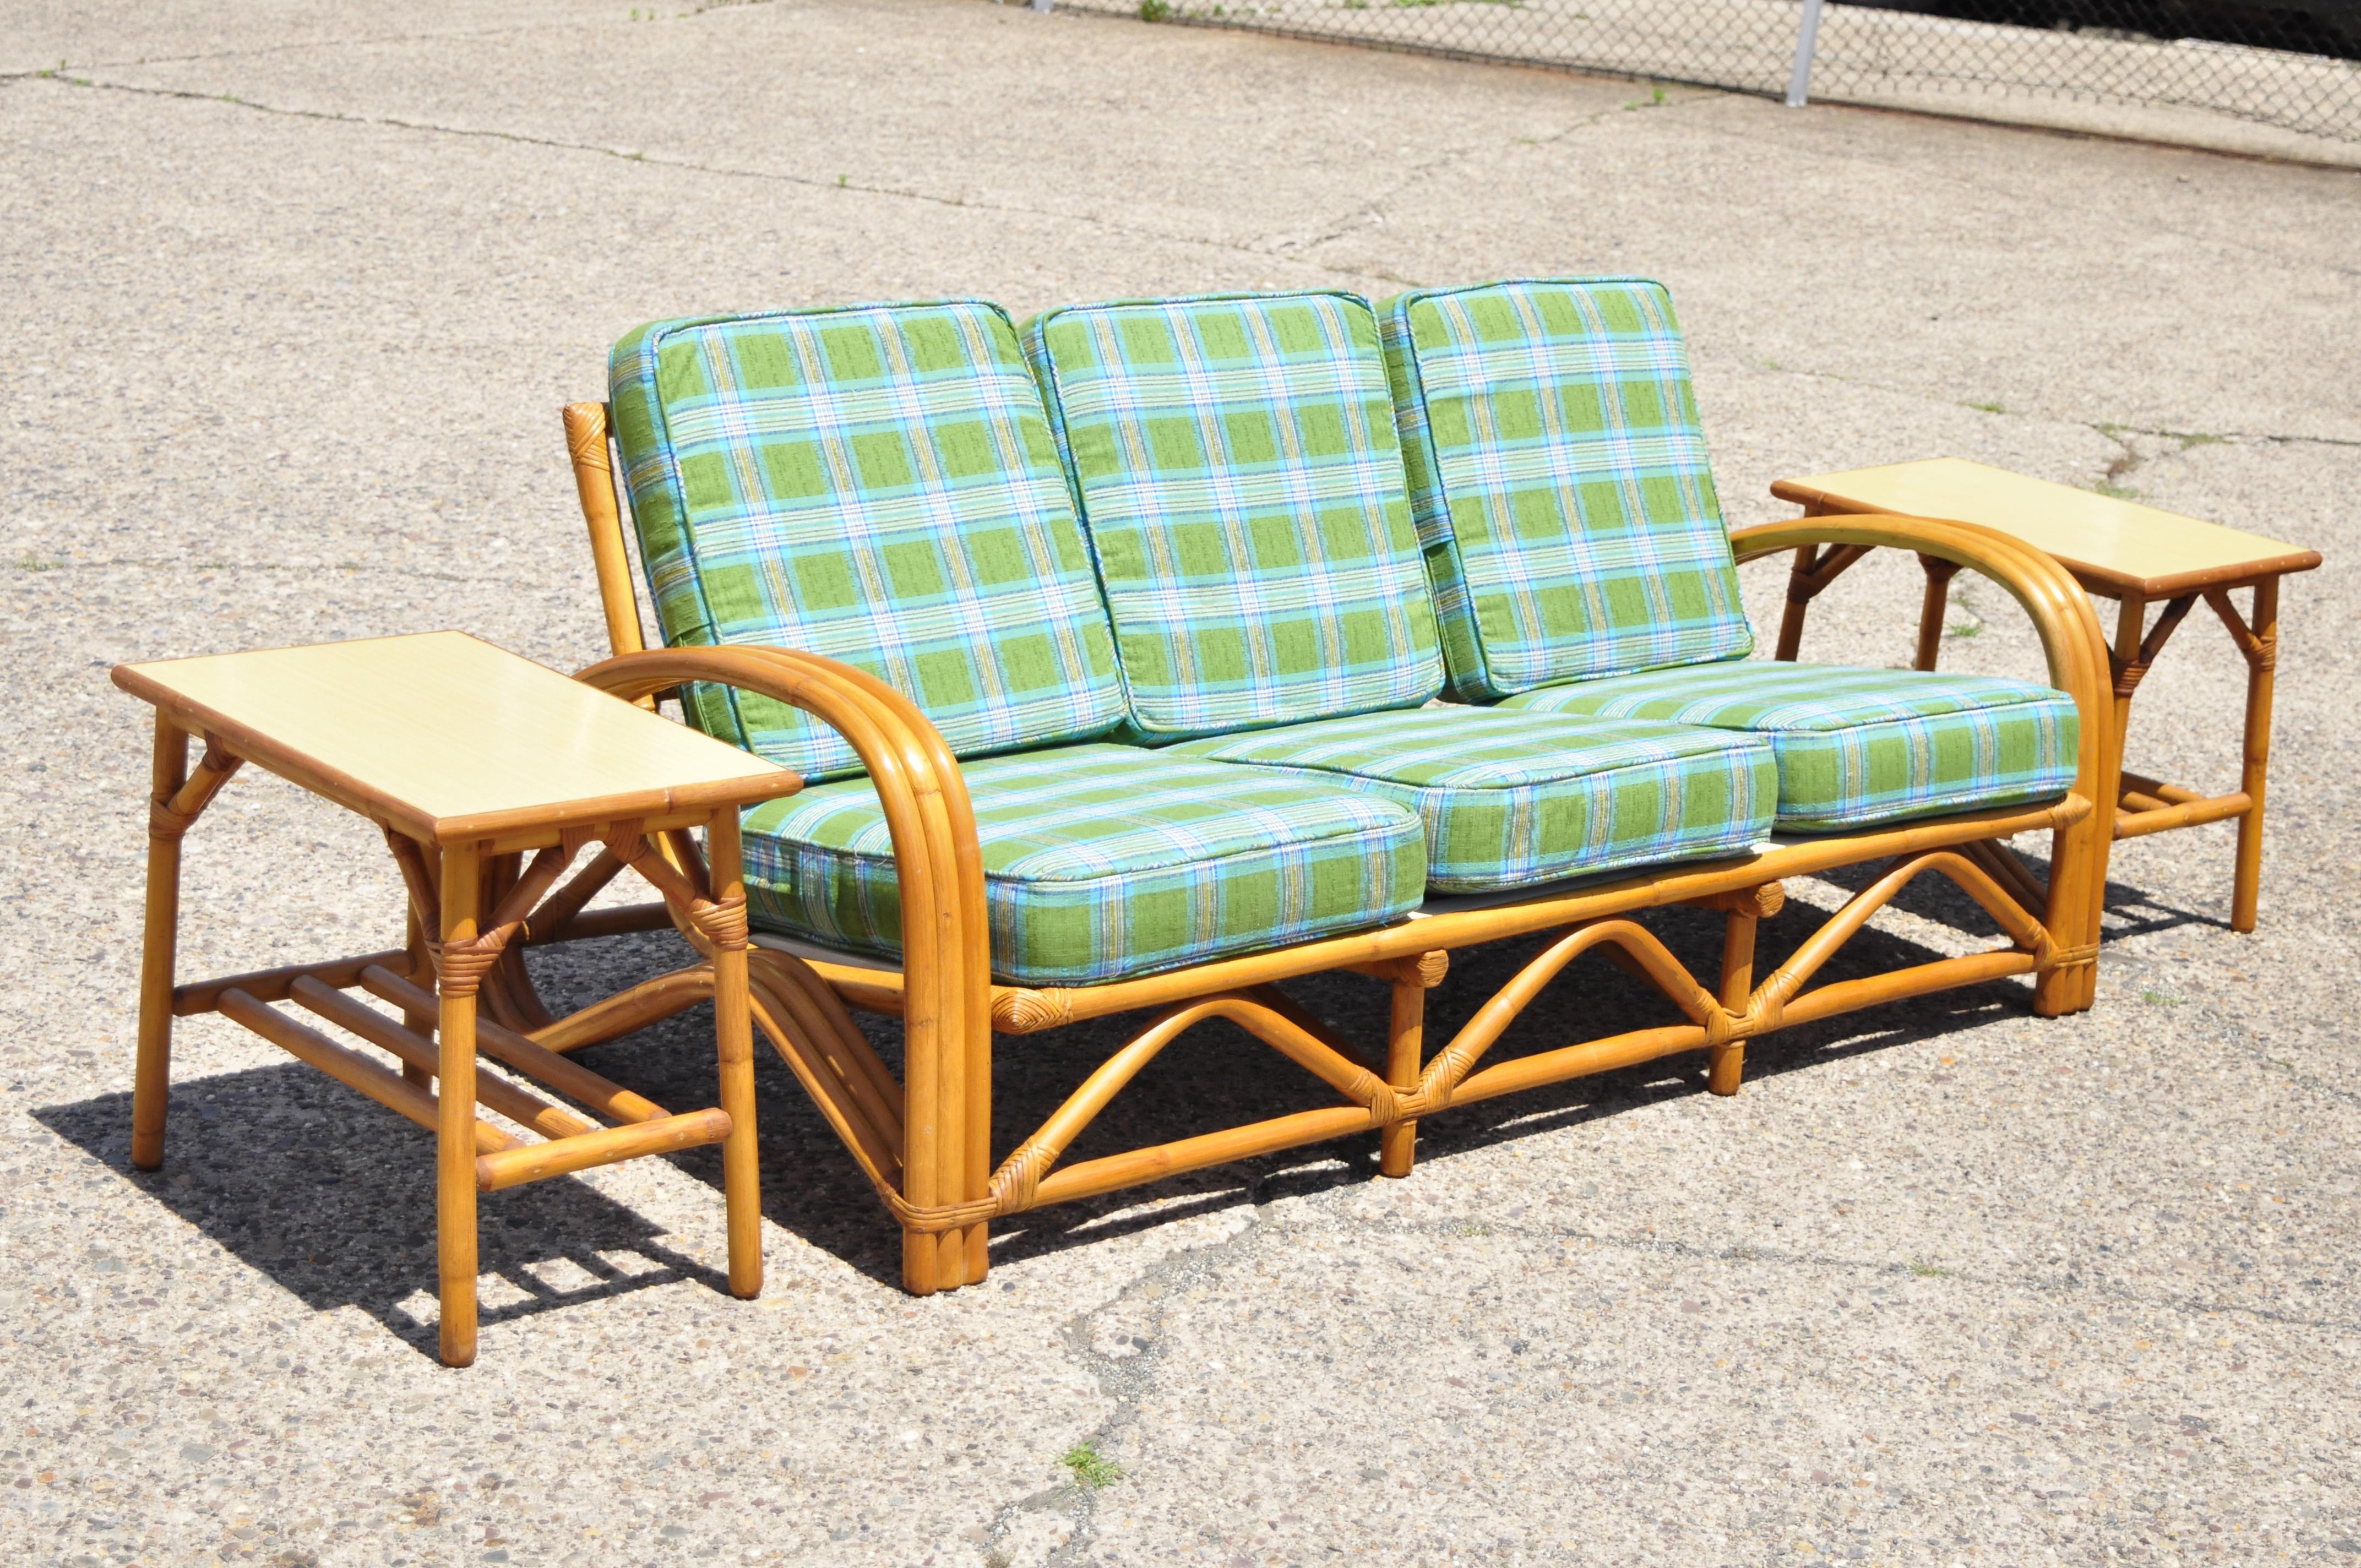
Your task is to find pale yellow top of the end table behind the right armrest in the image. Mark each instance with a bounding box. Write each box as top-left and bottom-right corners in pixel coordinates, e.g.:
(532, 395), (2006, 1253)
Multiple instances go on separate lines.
(1771, 458), (2321, 600)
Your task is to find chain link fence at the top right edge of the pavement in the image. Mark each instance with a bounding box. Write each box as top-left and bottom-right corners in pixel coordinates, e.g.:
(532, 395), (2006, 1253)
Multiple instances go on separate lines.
(1032, 0), (2361, 163)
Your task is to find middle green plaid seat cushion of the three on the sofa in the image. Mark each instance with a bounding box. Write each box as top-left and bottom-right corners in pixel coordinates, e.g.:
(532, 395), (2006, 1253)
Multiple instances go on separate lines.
(1169, 709), (1778, 892)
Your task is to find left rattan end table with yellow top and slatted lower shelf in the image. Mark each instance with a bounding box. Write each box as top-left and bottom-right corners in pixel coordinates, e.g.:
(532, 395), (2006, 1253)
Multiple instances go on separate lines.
(113, 633), (801, 1367)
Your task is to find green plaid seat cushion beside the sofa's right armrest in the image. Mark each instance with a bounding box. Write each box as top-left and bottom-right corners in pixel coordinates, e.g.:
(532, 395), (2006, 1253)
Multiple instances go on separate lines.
(1502, 659), (2080, 831)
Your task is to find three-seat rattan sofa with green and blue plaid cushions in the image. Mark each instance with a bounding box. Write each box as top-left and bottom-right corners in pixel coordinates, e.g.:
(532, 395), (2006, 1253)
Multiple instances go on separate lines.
(540, 279), (2113, 1294)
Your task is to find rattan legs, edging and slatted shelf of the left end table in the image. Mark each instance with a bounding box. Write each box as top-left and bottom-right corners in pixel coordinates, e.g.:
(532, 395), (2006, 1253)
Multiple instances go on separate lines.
(113, 633), (801, 1367)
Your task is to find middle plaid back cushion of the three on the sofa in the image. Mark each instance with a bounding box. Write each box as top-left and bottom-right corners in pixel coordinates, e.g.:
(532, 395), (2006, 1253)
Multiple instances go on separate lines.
(1025, 293), (1443, 742)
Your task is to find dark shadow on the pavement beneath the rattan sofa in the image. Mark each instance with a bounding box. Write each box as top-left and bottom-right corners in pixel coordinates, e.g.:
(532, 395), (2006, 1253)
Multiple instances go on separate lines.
(521, 879), (2087, 1287)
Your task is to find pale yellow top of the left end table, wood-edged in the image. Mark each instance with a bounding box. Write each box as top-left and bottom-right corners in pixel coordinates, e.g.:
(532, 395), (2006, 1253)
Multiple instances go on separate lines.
(113, 630), (801, 843)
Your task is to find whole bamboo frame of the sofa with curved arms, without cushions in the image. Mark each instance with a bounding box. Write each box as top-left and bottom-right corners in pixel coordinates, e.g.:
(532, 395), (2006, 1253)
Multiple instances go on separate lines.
(517, 401), (2118, 1294)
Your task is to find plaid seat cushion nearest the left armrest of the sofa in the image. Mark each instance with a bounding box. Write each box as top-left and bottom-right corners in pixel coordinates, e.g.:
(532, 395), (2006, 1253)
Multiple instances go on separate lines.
(746, 746), (1426, 985)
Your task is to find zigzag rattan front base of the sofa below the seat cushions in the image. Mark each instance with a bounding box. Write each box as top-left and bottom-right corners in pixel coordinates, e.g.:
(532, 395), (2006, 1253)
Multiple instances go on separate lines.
(576, 633), (2094, 1282)
